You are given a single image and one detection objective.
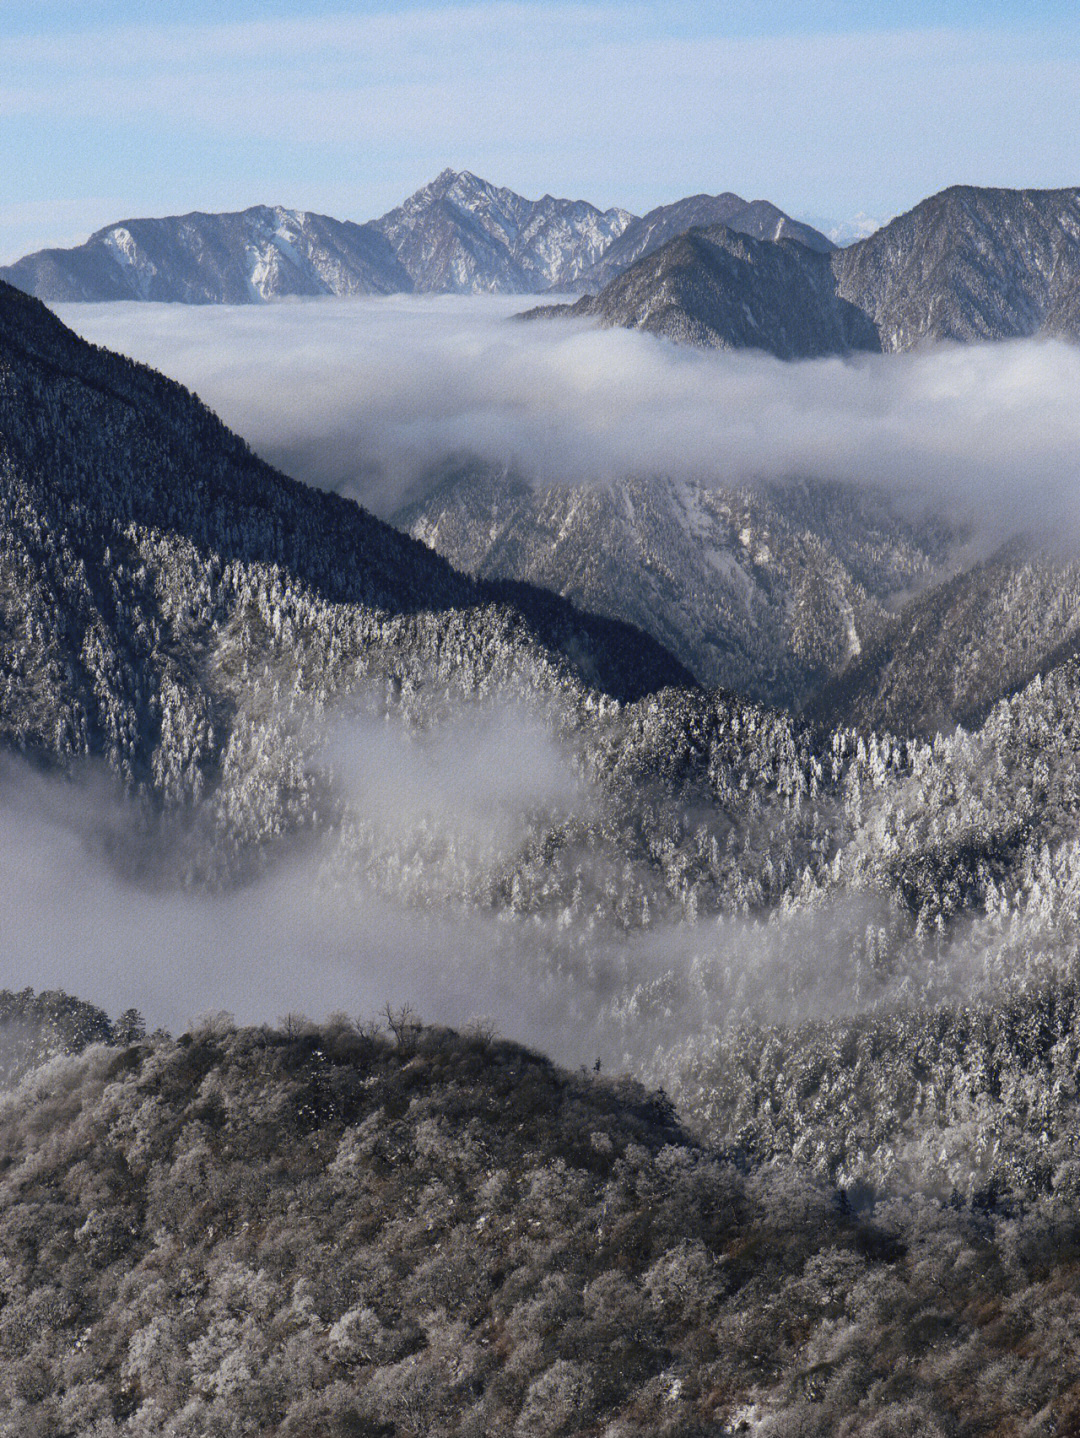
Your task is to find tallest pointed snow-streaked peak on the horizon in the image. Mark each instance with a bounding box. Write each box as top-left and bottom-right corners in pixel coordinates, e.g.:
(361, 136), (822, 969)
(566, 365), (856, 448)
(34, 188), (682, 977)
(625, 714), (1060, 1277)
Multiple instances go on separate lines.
(374, 170), (633, 293)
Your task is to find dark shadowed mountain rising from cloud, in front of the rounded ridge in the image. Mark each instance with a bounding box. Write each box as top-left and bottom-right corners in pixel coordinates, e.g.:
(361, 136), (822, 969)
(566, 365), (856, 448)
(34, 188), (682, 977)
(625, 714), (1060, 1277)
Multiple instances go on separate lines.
(526, 224), (879, 360)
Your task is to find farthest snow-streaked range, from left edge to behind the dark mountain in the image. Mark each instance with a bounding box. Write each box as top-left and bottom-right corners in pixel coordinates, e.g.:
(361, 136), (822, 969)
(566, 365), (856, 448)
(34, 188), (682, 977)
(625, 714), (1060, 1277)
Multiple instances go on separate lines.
(0, 170), (833, 305)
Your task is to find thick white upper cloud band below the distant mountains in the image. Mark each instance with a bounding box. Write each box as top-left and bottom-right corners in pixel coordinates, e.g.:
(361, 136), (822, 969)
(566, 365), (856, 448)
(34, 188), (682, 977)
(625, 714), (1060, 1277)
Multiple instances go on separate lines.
(60, 296), (1080, 538)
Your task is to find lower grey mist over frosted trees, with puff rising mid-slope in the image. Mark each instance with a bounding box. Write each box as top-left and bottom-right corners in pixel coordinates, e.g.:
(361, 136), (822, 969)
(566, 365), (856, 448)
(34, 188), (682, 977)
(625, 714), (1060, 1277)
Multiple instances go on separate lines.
(0, 705), (1023, 1074)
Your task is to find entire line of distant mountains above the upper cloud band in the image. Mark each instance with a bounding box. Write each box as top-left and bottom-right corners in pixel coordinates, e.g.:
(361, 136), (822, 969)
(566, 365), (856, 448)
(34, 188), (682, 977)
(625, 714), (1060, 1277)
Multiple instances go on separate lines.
(8, 170), (1080, 360)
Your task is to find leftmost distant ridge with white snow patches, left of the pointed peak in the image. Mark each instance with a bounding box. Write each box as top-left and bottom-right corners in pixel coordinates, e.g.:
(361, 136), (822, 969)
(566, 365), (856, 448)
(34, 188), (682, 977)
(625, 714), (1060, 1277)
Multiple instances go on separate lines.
(0, 206), (411, 305)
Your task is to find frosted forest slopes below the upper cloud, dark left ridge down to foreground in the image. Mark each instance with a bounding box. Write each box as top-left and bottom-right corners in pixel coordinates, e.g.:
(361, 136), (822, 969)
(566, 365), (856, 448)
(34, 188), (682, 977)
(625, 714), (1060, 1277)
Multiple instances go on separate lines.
(0, 271), (1080, 1438)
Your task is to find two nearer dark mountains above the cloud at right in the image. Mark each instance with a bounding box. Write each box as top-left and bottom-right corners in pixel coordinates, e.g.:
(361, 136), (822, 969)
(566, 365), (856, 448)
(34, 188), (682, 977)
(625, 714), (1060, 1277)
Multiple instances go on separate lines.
(531, 186), (1080, 360)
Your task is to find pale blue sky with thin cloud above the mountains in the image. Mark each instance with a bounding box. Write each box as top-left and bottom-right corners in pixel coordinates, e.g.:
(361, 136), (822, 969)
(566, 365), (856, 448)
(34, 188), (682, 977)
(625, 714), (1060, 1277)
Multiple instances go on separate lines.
(0, 0), (1080, 259)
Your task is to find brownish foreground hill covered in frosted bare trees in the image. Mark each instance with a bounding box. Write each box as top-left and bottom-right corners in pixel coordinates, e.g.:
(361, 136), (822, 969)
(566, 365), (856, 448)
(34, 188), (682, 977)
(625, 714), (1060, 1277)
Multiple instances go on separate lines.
(0, 995), (1080, 1438)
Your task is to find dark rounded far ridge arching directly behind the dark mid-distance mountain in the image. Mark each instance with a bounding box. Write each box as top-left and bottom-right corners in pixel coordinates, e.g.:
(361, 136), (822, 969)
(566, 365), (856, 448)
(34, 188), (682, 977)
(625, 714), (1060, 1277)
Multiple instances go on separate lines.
(580, 191), (836, 290)
